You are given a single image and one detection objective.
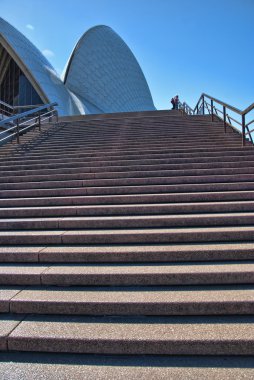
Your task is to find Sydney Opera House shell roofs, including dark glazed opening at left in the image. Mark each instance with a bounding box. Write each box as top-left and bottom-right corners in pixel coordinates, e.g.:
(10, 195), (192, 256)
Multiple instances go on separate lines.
(0, 18), (155, 115)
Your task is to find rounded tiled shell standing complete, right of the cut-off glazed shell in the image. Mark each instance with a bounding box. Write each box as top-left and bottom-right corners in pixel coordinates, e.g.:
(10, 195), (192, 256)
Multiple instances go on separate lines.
(64, 25), (155, 113)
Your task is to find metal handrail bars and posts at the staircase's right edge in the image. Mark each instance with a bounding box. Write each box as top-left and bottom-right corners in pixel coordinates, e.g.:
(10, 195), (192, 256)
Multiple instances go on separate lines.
(194, 93), (254, 146)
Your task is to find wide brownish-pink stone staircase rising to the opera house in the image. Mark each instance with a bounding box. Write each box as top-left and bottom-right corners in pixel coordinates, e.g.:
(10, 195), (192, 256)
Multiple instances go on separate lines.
(0, 111), (254, 380)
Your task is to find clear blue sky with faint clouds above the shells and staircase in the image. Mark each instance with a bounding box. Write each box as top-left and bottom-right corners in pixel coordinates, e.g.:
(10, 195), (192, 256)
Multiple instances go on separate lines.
(0, 0), (254, 109)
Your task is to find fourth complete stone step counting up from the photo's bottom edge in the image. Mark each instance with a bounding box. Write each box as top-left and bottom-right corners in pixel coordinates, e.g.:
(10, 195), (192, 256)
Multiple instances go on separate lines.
(0, 242), (254, 263)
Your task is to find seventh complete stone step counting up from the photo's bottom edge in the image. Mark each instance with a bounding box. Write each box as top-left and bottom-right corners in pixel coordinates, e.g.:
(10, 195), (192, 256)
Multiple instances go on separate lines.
(0, 200), (254, 218)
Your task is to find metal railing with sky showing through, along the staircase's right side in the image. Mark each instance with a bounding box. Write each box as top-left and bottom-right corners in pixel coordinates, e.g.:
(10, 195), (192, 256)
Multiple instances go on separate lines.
(194, 94), (254, 146)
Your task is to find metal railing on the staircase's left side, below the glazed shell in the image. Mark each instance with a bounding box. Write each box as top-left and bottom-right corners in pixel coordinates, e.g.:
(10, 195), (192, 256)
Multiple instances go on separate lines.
(0, 103), (58, 145)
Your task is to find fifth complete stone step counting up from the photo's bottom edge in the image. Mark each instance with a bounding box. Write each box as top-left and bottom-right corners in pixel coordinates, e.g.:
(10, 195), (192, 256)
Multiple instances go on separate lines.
(0, 226), (254, 245)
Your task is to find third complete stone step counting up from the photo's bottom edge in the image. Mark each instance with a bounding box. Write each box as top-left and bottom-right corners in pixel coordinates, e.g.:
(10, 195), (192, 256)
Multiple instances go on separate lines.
(0, 261), (254, 286)
